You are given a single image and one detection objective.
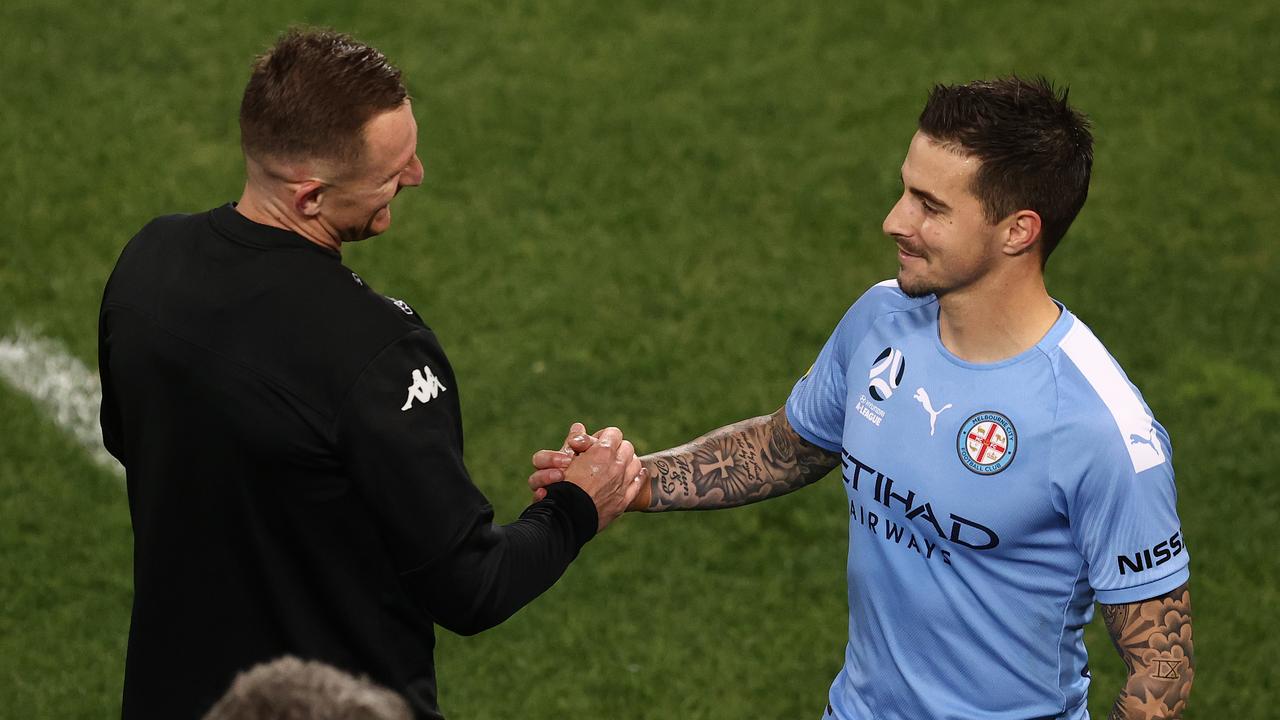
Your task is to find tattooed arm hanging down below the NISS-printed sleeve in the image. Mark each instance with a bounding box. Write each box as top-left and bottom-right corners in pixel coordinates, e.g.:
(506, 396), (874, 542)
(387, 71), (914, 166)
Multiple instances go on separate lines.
(1102, 584), (1196, 720)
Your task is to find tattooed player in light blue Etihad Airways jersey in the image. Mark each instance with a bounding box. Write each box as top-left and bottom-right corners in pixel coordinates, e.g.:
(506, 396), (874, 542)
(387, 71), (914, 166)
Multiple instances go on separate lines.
(530, 77), (1194, 720)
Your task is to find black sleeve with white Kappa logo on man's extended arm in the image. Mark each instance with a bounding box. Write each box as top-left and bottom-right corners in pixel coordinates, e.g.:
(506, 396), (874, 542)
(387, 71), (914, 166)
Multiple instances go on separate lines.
(335, 328), (598, 634)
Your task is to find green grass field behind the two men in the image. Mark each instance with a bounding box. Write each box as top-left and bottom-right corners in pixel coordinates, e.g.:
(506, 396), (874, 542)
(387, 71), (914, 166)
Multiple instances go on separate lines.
(0, 0), (1280, 720)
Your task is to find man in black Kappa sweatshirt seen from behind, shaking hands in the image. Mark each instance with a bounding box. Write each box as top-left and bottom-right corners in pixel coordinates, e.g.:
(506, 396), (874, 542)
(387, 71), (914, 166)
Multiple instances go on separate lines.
(99, 31), (643, 720)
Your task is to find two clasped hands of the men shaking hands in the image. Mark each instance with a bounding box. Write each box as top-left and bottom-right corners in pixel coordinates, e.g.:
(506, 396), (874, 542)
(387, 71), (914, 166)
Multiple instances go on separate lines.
(529, 423), (649, 532)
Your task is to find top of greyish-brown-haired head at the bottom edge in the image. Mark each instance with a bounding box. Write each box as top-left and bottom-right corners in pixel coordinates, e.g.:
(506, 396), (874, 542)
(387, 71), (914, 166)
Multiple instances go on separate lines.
(204, 656), (412, 720)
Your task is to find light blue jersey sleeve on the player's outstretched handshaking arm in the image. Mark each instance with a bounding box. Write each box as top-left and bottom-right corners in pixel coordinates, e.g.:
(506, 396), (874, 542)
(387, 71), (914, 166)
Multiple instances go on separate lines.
(786, 281), (900, 452)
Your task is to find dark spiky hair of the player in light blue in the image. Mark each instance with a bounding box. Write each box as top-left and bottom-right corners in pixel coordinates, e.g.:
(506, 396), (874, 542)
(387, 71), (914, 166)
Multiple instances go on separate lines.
(919, 76), (1093, 261)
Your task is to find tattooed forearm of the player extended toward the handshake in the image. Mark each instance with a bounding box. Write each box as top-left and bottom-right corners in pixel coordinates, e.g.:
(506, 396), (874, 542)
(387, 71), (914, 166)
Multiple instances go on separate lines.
(641, 409), (840, 512)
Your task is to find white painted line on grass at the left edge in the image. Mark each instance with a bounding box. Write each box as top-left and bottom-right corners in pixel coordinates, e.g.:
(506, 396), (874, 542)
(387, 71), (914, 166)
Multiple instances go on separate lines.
(0, 329), (124, 475)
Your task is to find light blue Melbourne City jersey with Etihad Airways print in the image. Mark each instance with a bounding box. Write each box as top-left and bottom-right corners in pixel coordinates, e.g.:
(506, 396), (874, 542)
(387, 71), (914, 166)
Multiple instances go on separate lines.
(786, 281), (1189, 720)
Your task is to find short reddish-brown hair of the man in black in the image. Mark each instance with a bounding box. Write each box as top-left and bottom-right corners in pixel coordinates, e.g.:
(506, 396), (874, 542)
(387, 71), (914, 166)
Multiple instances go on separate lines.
(239, 27), (408, 164)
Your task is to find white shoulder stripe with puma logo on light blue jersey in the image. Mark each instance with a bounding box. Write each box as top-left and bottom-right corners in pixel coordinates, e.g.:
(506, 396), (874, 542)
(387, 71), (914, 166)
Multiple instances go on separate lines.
(1060, 318), (1165, 473)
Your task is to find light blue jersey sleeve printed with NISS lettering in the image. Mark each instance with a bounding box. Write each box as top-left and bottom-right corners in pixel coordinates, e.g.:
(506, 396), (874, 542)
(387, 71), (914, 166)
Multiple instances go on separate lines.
(1069, 421), (1190, 605)
